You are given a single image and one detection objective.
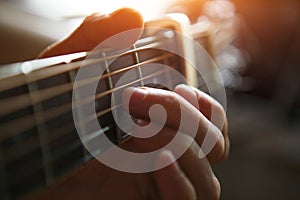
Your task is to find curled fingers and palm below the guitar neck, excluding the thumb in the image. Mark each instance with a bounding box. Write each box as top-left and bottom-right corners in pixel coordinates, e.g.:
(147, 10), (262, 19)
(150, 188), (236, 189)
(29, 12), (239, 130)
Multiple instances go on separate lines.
(35, 85), (229, 199)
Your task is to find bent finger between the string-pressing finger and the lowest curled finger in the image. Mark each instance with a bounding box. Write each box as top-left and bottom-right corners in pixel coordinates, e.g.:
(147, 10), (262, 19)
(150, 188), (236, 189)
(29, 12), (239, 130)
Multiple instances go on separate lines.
(131, 128), (220, 199)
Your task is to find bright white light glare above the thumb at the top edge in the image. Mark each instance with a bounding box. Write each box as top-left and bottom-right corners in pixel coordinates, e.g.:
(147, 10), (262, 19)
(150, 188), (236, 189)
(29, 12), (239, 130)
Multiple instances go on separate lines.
(26, 0), (176, 19)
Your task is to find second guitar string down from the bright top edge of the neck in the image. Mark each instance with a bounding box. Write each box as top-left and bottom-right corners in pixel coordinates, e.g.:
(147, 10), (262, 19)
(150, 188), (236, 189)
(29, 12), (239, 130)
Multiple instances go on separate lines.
(0, 54), (171, 115)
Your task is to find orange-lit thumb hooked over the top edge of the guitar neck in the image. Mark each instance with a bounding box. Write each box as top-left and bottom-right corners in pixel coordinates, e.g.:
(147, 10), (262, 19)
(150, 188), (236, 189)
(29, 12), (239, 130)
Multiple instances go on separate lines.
(39, 8), (144, 58)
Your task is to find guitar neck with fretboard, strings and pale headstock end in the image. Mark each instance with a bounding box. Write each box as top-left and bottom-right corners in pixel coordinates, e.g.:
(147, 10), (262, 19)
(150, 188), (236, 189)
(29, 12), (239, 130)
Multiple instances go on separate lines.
(0, 15), (223, 199)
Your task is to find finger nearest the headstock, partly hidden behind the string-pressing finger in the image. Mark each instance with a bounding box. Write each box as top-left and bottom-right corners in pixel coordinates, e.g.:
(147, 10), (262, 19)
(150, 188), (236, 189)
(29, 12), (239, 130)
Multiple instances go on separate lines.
(174, 84), (230, 160)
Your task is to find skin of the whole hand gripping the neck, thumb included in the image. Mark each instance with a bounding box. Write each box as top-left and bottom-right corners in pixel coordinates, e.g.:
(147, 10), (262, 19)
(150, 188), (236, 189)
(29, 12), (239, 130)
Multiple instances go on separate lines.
(34, 8), (229, 200)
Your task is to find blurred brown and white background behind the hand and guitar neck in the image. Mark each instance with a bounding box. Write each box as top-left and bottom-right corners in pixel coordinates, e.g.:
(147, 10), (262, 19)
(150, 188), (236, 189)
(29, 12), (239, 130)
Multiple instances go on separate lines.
(0, 0), (300, 200)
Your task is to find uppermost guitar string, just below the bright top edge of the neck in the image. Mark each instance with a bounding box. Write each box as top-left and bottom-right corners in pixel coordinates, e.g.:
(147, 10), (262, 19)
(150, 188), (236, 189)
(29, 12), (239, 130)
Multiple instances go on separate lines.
(0, 41), (166, 92)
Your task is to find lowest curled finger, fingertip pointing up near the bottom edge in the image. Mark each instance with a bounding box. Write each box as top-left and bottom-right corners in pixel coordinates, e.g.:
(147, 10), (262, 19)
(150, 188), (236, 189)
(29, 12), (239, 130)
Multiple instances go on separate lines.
(154, 151), (197, 200)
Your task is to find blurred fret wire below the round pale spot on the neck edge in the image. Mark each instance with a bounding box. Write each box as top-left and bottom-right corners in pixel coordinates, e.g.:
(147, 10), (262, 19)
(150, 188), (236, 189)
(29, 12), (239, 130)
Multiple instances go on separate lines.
(28, 82), (54, 185)
